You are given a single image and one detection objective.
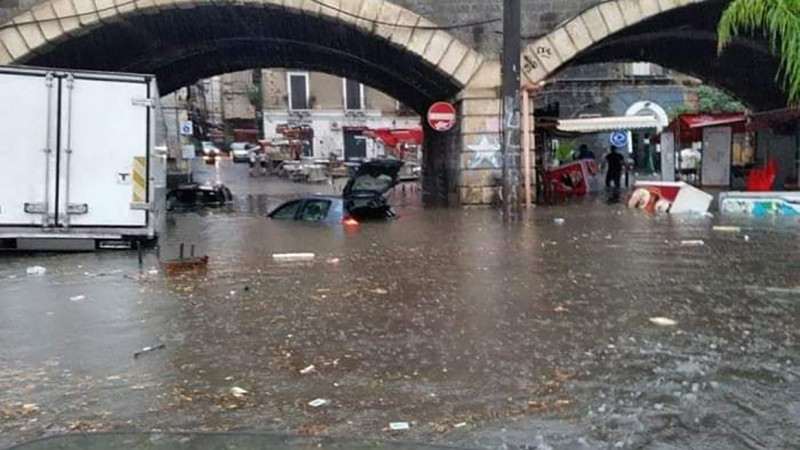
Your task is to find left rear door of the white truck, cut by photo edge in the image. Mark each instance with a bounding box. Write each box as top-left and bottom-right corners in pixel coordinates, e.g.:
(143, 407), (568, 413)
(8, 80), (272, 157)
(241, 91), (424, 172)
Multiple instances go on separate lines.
(0, 70), (57, 226)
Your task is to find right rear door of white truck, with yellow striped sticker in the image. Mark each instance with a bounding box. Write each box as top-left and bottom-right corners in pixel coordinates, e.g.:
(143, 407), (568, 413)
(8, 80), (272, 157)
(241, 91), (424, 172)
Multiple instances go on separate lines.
(58, 74), (150, 227)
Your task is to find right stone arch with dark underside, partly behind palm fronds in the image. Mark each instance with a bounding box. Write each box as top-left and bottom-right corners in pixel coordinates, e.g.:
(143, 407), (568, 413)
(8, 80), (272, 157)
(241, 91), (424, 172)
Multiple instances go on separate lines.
(521, 0), (787, 110)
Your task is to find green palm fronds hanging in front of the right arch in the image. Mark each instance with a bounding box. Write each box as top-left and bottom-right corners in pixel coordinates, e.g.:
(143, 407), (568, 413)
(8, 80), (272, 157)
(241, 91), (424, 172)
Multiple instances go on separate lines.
(717, 0), (800, 103)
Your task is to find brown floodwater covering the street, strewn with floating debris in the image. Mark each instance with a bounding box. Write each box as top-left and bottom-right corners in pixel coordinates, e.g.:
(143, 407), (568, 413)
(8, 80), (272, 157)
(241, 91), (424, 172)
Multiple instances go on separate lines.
(0, 163), (800, 449)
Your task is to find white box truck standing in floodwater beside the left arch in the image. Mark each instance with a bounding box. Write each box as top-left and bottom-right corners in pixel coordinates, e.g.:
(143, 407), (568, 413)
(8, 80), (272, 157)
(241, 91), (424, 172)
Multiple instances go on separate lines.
(0, 66), (167, 250)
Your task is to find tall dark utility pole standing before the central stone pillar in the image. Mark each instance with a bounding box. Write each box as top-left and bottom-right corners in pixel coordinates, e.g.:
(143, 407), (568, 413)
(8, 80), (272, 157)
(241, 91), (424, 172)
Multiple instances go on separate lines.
(502, 0), (522, 221)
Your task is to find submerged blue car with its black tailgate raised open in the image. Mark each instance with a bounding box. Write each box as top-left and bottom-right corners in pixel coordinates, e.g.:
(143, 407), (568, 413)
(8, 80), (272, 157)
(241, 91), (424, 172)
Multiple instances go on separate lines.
(269, 160), (403, 223)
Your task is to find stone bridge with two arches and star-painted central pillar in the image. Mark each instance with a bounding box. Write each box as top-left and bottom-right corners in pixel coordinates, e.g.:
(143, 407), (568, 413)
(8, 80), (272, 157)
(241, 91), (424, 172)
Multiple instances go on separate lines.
(0, 0), (786, 204)
